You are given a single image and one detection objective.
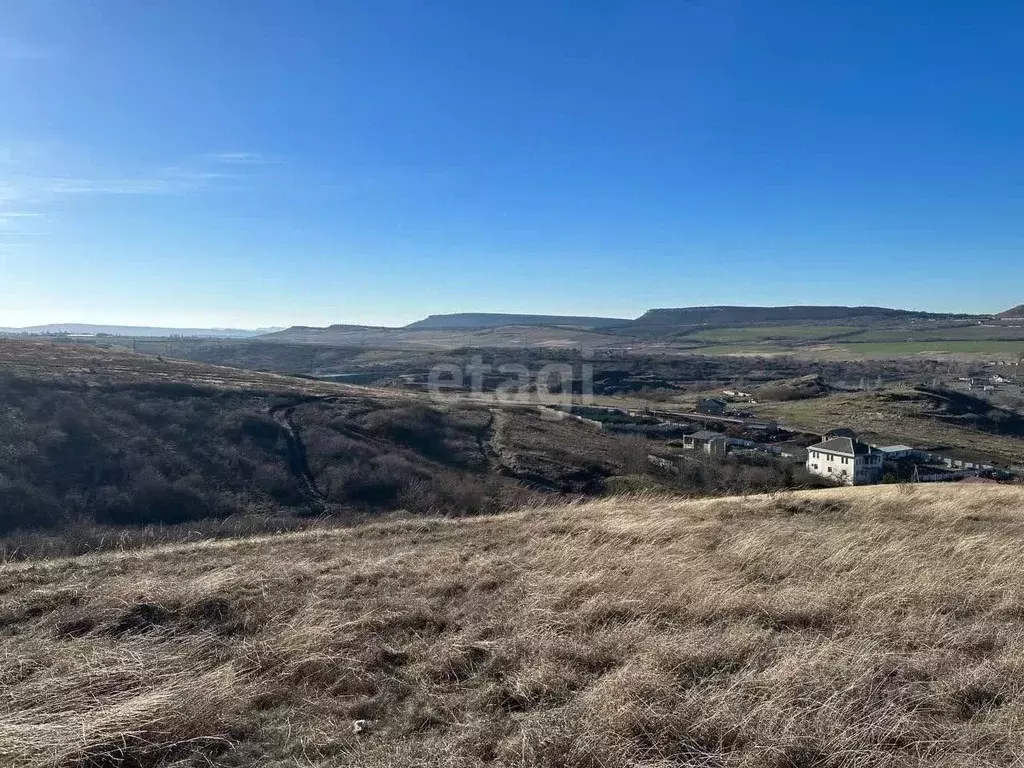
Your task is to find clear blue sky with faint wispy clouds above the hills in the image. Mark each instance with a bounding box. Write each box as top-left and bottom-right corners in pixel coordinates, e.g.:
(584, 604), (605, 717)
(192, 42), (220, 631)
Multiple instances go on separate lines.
(0, 0), (1024, 327)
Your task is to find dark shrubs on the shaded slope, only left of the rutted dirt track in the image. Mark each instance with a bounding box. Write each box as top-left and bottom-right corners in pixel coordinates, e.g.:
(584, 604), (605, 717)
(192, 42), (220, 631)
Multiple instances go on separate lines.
(0, 379), (301, 534)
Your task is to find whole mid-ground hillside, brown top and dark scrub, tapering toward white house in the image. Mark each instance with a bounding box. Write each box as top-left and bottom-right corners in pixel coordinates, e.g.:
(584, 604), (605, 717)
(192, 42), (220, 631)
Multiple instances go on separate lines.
(0, 342), (888, 558)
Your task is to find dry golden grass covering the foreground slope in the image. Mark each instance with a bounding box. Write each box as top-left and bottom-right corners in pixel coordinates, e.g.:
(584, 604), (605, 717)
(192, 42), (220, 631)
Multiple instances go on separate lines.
(6, 486), (1024, 768)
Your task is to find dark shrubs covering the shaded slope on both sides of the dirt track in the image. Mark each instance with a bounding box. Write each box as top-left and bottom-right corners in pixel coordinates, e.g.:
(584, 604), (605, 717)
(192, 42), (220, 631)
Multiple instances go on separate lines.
(0, 366), (535, 557)
